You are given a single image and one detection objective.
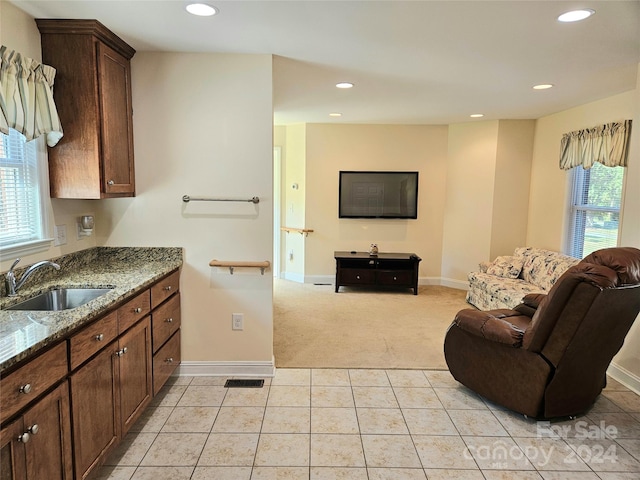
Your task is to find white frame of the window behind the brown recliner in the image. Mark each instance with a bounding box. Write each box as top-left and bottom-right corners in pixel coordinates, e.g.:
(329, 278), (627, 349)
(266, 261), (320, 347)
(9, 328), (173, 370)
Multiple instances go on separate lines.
(564, 164), (628, 259)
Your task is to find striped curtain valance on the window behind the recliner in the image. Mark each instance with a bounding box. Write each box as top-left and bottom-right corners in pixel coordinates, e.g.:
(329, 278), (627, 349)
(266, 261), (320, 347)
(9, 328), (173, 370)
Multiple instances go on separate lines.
(560, 120), (631, 170)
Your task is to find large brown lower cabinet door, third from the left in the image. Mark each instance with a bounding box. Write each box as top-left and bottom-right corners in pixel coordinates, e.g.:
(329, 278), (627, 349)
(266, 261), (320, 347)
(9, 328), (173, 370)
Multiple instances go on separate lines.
(70, 342), (120, 480)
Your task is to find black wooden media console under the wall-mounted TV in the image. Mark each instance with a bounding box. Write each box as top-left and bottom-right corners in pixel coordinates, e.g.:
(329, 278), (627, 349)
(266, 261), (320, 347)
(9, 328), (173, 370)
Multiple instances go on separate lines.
(334, 252), (422, 295)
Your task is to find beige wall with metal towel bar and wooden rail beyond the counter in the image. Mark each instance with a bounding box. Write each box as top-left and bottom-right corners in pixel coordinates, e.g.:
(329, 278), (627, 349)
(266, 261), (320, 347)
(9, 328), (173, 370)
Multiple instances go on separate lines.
(94, 52), (273, 365)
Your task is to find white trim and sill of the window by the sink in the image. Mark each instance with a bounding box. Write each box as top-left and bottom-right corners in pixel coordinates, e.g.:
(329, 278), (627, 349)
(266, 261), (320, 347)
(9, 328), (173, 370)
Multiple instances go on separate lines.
(0, 128), (53, 259)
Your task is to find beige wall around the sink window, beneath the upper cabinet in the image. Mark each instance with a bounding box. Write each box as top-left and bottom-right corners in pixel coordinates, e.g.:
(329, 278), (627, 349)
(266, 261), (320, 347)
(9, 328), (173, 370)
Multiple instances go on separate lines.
(0, 1), (96, 271)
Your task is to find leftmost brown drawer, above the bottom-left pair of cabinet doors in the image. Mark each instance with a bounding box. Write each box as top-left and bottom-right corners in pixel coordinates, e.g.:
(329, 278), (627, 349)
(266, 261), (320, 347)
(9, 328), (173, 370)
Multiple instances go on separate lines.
(0, 342), (69, 422)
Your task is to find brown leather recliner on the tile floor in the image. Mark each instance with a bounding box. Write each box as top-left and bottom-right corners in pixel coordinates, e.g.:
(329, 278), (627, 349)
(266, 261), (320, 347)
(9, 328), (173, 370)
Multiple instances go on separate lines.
(444, 247), (640, 418)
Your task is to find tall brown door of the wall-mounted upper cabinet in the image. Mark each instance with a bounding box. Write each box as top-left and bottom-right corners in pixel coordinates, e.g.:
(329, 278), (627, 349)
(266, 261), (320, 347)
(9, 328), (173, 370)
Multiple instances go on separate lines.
(98, 43), (135, 196)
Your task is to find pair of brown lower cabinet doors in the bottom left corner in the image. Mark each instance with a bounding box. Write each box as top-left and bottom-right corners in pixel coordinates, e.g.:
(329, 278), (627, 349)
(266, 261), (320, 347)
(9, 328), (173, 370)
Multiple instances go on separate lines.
(0, 380), (73, 480)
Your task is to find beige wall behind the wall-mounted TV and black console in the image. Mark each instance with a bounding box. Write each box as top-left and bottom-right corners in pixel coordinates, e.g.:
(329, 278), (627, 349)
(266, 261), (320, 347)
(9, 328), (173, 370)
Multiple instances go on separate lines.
(296, 124), (447, 281)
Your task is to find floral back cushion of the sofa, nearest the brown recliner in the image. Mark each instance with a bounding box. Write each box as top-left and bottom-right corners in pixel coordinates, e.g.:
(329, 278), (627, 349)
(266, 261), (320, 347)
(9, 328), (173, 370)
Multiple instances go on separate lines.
(520, 248), (579, 292)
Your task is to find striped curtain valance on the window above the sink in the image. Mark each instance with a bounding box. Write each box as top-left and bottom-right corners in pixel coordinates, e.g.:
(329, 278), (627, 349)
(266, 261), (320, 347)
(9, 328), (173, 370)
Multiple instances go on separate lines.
(0, 45), (62, 147)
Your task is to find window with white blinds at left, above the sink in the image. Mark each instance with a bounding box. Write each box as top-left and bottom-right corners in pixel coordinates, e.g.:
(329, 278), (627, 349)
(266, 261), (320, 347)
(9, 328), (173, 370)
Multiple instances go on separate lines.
(0, 129), (48, 255)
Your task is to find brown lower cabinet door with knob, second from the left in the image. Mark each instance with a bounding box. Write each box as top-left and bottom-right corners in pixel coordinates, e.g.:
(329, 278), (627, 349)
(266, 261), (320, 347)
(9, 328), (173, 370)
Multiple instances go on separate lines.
(23, 381), (73, 480)
